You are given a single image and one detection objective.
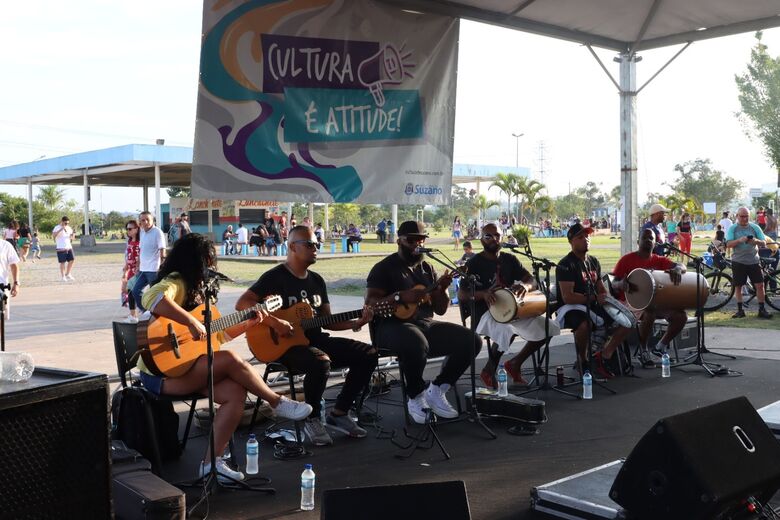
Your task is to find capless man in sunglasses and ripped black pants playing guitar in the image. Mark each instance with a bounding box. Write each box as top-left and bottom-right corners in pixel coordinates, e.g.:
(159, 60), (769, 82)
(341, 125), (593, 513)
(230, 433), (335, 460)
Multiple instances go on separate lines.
(236, 226), (377, 446)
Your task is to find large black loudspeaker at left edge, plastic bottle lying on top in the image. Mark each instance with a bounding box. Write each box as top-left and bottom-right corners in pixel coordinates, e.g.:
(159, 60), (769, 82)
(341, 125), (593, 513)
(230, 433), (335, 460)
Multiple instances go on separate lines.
(0, 367), (111, 519)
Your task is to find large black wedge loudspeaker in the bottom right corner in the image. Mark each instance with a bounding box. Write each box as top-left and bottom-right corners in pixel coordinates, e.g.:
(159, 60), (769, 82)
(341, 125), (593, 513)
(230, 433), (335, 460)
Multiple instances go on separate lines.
(609, 397), (780, 520)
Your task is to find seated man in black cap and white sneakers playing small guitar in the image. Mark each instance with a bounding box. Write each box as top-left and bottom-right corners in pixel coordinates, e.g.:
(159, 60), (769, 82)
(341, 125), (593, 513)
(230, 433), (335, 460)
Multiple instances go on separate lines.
(366, 220), (482, 424)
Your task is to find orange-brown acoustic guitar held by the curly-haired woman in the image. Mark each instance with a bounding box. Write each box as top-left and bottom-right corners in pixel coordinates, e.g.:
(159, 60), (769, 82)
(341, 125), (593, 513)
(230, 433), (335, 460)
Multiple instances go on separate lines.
(137, 295), (282, 377)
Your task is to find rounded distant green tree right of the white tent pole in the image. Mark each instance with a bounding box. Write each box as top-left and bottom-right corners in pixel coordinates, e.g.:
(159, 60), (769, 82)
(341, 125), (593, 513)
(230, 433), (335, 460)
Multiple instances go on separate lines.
(667, 159), (744, 214)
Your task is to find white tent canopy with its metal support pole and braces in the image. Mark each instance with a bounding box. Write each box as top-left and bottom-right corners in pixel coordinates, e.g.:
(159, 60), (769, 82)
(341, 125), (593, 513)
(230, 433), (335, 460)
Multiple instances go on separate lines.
(381, 0), (780, 254)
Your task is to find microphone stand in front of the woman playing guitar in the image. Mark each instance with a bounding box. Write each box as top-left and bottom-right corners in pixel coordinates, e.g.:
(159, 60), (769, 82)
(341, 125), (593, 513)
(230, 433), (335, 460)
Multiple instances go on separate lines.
(180, 275), (276, 517)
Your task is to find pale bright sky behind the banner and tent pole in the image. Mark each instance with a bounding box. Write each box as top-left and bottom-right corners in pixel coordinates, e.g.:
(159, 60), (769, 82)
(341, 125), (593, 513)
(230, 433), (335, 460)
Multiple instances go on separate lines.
(0, 0), (780, 212)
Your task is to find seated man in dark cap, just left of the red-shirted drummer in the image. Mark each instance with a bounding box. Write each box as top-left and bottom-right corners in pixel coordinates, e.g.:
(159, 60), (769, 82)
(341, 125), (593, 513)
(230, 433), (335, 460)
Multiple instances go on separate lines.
(555, 224), (631, 378)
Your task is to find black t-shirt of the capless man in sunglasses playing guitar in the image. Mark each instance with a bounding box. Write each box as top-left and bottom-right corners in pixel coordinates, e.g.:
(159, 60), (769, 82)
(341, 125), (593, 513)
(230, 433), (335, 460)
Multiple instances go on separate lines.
(249, 264), (330, 341)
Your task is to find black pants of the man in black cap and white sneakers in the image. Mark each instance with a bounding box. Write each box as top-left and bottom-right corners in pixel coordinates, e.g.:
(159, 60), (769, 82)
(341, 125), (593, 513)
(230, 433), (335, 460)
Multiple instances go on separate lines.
(374, 319), (482, 397)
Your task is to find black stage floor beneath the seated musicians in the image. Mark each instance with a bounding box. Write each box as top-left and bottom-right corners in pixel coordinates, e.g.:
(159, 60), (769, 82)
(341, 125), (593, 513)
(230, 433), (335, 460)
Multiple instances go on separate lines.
(165, 345), (780, 520)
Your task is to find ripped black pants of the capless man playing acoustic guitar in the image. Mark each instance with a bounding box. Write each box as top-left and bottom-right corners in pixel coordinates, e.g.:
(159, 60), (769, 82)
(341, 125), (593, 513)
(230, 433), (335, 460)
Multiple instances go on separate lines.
(279, 334), (377, 417)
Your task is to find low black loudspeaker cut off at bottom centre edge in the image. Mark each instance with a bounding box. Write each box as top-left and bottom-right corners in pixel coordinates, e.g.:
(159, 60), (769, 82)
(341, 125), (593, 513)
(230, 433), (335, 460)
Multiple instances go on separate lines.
(320, 480), (471, 520)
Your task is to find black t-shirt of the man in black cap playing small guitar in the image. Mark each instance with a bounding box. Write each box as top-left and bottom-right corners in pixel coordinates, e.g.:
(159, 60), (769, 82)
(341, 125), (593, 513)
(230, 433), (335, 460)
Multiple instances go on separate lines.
(366, 253), (436, 320)
